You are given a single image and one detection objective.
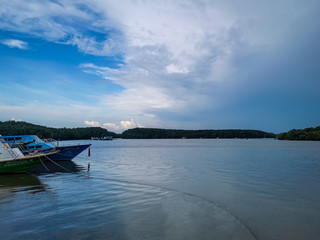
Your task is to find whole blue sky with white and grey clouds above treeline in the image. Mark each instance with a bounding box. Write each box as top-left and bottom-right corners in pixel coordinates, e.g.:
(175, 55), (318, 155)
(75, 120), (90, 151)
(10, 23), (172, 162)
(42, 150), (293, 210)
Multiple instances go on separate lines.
(0, 0), (320, 133)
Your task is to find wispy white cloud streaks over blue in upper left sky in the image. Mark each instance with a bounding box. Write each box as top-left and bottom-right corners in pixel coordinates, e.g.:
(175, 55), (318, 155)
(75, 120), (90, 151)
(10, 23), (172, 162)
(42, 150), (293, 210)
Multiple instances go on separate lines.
(0, 0), (122, 56)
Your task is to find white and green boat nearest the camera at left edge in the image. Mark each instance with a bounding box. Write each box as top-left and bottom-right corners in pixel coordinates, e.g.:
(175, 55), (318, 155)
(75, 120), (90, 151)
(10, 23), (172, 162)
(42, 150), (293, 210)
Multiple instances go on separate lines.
(0, 135), (59, 173)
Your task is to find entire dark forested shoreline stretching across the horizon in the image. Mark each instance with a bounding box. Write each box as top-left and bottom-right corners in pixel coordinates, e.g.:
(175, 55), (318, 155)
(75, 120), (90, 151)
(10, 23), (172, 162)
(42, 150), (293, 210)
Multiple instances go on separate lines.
(0, 121), (320, 140)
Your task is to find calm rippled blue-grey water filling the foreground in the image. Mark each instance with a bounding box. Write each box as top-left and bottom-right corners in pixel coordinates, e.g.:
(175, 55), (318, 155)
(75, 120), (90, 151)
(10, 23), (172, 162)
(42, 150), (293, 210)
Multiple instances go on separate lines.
(0, 139), (320, 240)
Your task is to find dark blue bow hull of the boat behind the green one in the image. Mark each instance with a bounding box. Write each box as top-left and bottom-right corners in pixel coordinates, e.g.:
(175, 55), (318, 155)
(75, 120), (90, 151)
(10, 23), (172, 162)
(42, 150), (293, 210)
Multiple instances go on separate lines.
(50, 144), (91, 161)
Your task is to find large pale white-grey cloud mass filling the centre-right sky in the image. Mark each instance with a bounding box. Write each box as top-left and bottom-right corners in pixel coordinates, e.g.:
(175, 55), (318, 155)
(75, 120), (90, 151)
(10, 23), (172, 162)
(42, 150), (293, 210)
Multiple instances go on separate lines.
(79, 0), (315, 125)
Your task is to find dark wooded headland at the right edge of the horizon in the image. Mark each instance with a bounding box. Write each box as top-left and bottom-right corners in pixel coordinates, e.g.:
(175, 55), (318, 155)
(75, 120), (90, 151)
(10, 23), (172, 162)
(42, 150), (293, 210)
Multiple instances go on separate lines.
(277, 126), (320, 141)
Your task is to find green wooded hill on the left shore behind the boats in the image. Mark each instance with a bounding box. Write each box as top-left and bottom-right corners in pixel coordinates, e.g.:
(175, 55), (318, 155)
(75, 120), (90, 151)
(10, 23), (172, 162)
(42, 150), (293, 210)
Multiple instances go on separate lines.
(0, 121), (118, 140)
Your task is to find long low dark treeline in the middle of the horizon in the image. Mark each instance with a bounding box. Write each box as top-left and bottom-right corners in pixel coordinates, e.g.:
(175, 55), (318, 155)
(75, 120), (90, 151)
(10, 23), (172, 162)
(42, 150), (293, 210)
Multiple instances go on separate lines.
(121, 128), (275, 139)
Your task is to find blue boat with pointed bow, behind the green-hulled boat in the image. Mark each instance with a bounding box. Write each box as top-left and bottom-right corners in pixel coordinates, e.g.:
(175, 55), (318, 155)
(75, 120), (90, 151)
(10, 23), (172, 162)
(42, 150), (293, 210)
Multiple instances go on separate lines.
(3, 135), (91, 161)
